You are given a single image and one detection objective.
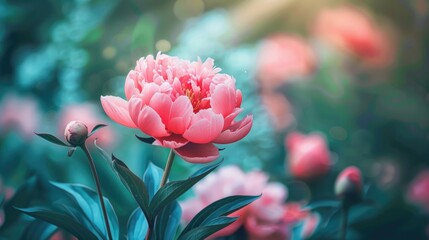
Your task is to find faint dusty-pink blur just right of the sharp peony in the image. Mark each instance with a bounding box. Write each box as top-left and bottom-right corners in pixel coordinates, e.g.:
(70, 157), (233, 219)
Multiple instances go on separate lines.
(261, 92), (295, 131)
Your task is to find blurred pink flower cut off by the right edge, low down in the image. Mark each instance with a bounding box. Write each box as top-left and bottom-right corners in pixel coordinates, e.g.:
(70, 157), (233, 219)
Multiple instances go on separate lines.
(407, 170), (429, 212)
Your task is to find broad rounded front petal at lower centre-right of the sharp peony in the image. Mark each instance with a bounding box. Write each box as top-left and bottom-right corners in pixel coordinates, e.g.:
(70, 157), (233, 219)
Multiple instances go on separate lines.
(183, 110), (223, 144)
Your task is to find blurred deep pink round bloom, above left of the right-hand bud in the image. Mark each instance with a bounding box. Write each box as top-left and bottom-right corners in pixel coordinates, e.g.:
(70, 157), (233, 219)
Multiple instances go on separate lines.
(285, 132), (332, 180)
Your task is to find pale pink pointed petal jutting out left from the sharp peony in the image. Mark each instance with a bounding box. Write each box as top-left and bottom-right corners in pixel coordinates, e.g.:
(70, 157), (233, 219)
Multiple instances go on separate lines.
(100, 96), (136, 128)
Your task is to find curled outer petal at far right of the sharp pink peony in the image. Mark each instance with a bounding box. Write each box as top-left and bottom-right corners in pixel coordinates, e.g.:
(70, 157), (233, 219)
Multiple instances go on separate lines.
(213, 115), (253, 144)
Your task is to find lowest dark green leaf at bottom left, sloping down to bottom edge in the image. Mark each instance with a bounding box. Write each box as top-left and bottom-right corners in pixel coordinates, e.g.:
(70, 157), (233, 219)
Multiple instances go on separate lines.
(17, 207), (98, 240)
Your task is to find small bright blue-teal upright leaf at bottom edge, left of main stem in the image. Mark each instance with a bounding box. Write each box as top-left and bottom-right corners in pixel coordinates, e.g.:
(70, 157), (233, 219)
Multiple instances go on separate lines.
(127, 208), (149, 240)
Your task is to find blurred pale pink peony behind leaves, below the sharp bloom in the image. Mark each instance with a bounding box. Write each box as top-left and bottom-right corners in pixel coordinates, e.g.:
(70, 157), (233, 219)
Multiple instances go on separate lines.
(180, 166), (317, 240)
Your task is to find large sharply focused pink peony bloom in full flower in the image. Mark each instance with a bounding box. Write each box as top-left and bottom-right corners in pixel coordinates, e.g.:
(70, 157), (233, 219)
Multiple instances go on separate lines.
(101, 54), (253, 163)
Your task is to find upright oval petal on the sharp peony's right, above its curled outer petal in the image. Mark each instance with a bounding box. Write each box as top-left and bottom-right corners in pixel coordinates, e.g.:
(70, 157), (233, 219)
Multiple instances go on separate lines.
(210, 84), (237, 117)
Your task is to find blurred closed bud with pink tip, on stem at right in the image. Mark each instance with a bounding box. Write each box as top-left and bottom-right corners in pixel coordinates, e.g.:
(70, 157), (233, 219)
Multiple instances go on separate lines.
(335, 166), (362, 203)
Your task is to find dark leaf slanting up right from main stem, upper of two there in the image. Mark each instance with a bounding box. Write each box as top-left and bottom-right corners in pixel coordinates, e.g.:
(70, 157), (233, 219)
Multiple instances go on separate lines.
(149, 162), (222, 216)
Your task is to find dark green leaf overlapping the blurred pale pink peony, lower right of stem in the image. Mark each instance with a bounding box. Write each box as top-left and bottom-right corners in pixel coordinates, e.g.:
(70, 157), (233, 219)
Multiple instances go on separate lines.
(182, 195), (260, 234)
